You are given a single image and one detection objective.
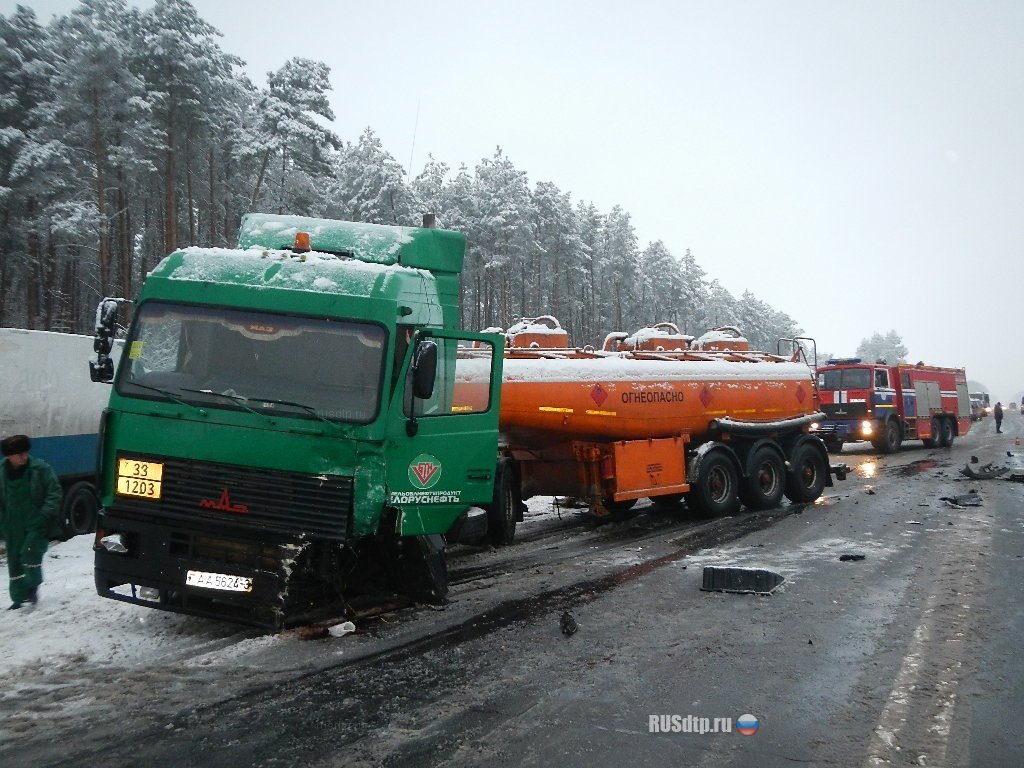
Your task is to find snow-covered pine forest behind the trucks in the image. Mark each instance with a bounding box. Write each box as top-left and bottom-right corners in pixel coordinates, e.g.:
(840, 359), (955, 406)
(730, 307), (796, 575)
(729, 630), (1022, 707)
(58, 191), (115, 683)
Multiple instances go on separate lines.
(0, 0), (799, 348)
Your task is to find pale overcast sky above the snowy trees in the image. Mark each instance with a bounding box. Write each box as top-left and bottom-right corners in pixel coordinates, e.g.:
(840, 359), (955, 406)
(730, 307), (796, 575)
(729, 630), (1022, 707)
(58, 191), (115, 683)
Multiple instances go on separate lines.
(6, 0), (1024, 402)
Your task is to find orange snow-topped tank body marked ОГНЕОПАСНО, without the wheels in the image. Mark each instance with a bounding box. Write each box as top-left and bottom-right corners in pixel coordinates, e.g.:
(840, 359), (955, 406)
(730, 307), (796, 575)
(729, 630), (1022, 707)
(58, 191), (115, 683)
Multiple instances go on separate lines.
(487, 324), (818, 447)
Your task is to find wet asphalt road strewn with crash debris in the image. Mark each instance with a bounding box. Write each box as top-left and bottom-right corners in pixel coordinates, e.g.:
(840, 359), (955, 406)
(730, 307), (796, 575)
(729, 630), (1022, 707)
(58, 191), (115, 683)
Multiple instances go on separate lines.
(5, 412), (1024, 768)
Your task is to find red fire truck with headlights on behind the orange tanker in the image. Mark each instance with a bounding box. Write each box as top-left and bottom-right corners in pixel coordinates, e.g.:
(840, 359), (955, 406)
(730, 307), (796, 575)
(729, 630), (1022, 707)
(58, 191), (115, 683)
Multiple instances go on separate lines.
(816, 357), (971, 454)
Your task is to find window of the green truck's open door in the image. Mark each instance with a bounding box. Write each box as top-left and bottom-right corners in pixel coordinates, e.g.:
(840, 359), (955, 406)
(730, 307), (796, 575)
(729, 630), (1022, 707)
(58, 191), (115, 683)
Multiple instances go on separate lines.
(406, 338), (494, 418)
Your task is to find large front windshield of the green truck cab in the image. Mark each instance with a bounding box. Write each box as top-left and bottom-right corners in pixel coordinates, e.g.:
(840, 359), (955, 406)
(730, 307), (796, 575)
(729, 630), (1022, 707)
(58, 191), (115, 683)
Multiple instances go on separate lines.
(118, 302), (385, 424)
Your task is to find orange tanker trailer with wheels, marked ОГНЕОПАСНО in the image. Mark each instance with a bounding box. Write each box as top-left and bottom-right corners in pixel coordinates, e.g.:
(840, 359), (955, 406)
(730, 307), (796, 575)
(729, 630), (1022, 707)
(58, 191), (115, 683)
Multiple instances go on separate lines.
(466, 316), (845, 542)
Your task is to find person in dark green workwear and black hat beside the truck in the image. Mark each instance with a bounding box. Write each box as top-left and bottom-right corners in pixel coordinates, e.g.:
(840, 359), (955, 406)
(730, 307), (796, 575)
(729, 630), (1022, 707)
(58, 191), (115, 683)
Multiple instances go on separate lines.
(0, 434), (61, 610)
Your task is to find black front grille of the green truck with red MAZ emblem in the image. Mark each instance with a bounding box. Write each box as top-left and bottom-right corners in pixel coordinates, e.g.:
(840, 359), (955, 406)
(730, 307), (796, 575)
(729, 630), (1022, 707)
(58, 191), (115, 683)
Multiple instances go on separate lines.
(114, 455), (352, 541)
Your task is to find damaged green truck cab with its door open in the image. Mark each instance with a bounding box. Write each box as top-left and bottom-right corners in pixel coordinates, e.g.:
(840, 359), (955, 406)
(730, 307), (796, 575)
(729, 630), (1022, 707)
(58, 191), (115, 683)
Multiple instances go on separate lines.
(92, 214), (508, 629)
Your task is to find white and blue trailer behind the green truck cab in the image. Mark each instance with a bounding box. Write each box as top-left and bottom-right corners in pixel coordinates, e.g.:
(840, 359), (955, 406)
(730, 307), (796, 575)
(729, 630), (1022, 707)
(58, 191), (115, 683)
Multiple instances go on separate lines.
(0, 328), (120, 539)
